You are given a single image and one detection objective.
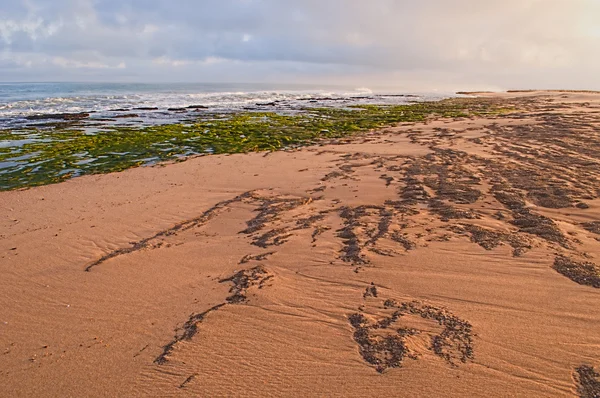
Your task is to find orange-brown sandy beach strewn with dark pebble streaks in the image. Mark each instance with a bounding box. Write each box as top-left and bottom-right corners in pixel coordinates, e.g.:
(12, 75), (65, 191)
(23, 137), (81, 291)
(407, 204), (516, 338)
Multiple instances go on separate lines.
(0, 92), (600, 398)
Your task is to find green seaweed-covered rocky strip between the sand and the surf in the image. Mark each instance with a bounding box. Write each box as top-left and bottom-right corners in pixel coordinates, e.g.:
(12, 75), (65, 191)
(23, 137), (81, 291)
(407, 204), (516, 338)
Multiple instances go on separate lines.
(0, 99), (502, 190)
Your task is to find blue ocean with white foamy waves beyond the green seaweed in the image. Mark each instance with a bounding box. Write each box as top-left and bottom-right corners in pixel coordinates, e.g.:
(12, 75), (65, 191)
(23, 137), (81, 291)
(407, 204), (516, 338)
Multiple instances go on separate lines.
(0, 83), (453, 128)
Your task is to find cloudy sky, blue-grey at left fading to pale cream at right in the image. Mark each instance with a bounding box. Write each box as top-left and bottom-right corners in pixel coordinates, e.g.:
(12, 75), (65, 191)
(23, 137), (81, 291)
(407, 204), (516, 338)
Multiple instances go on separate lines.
(0, 0), (600, 90)
